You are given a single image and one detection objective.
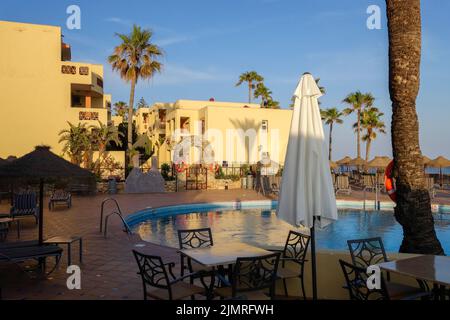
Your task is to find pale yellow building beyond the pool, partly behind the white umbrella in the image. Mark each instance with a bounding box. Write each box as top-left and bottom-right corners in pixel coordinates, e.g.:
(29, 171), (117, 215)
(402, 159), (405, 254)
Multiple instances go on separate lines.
(142, 100), (292, 166)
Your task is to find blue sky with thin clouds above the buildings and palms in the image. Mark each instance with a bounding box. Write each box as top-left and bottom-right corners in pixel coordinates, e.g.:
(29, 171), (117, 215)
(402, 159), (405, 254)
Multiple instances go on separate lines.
(0, 0), (450, 159)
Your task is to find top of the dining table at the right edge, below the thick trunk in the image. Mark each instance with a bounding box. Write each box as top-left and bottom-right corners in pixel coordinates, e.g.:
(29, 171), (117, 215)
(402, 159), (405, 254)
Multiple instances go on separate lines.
(379, 255), (450, 286)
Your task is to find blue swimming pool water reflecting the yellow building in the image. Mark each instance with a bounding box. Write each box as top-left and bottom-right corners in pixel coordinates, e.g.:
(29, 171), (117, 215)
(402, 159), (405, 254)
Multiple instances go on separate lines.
(135, 209), (450, 254)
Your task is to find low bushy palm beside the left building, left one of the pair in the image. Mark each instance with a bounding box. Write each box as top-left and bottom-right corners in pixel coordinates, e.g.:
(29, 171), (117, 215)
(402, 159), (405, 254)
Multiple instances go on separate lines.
(58, 122), (90, 165)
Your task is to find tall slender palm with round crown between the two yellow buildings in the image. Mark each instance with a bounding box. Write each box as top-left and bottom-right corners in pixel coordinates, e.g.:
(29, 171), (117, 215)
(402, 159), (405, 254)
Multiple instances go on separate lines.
(108, 25), (163, 159)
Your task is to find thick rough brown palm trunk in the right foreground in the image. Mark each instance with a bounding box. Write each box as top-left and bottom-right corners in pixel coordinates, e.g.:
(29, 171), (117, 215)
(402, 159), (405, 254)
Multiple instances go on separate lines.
(386, 0), (444, 254)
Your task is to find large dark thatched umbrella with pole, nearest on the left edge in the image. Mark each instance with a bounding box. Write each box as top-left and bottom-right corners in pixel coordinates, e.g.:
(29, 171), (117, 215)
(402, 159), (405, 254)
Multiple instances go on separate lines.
(0, 146), (95, 244)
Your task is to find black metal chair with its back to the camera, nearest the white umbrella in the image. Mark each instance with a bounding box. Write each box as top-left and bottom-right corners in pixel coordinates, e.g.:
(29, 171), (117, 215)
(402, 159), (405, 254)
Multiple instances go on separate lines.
(214, 252), (280, 300)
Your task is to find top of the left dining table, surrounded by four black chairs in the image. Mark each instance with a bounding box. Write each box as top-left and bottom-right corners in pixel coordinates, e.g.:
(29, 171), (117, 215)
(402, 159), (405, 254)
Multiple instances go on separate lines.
(180, 242), (273, 267)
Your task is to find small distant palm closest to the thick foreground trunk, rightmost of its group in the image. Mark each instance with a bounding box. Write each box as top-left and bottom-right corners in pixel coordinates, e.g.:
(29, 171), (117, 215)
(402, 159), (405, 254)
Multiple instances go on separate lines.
(353, 107), (386, 161)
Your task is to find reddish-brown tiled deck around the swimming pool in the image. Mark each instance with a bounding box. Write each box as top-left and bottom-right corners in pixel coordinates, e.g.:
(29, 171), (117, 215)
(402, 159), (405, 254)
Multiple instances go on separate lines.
(0, 189), (450, 300)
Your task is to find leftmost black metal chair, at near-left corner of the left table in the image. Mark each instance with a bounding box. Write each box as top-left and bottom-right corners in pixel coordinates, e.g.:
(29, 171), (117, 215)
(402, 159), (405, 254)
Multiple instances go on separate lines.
(133, 250), (205, 300)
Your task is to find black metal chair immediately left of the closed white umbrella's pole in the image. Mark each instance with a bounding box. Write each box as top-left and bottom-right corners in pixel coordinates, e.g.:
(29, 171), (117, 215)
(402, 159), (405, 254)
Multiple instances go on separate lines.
(277, 231), (311, 300)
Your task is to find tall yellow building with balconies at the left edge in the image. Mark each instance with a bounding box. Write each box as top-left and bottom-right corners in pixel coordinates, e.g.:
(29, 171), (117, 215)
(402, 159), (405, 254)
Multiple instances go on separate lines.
(0, 21), (111, 158)
